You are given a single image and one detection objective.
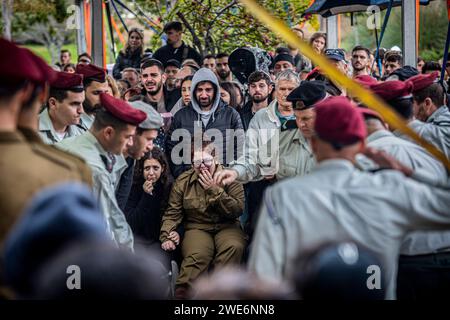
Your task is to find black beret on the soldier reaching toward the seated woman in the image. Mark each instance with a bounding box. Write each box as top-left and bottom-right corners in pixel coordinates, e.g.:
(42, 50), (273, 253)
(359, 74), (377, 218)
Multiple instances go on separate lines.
(286, 81), (327, 110)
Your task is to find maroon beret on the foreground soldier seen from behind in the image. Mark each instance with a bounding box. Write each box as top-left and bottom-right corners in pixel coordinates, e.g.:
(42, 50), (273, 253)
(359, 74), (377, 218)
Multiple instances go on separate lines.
(314, 96), (367, 145)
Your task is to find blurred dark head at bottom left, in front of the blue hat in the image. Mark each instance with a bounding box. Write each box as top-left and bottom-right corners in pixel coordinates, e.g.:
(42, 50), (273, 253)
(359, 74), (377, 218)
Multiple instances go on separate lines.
(32, 242), (170, 301)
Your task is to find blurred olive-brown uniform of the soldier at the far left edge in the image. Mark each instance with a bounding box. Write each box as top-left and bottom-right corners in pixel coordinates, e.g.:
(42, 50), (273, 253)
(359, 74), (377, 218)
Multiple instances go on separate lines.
(0, 131), (91, 248)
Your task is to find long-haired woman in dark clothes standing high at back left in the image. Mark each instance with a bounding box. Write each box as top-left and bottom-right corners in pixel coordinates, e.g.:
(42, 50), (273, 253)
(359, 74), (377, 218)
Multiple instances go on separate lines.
(113, 28), (144, 79)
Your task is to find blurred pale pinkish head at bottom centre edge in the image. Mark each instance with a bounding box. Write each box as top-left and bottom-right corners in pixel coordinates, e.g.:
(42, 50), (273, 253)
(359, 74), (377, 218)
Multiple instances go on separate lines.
(191, 267), (295, 300)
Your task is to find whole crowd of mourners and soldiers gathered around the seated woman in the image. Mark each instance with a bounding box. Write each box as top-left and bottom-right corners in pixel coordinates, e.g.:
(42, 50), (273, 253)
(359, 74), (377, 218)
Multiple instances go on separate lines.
(0, 21), (450, 300)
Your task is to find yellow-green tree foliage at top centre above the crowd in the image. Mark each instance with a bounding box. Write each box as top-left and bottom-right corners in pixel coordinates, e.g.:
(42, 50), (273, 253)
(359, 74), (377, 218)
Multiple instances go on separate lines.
(137, 0), (317, 53)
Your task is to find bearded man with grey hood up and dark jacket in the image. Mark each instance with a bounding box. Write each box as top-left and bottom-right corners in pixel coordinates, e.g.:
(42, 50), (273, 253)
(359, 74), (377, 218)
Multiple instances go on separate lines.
(166, 68), (244, 178)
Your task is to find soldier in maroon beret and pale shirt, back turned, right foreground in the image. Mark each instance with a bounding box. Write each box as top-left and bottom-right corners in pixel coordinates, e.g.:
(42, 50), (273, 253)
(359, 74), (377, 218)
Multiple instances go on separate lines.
(249, 97), (450, 299)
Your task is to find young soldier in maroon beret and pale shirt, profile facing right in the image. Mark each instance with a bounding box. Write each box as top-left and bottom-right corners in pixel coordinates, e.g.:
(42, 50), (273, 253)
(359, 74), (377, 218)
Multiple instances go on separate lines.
(57, 93), (147, 249)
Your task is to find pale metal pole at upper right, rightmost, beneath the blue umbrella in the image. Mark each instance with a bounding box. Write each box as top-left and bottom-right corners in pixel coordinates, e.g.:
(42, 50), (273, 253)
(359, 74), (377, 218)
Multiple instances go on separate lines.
(402, 0), (417, 67)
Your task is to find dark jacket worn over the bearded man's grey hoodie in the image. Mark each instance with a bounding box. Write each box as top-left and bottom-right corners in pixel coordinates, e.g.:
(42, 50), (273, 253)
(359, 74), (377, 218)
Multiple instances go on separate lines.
(166, 100), (244, 178)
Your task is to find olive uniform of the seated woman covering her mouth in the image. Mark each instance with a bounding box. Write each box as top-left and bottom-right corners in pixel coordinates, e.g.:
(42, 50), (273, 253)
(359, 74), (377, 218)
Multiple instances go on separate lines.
(160, 166), (246, 286)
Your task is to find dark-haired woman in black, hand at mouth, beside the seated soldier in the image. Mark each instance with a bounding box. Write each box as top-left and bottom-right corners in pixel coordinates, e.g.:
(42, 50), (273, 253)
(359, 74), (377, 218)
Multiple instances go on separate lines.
(125, 147), (180, 248)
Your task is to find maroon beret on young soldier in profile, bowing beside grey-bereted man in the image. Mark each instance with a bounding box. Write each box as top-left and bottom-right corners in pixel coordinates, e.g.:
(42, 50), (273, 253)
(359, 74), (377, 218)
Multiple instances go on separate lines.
(100, 93), (147, 126)
